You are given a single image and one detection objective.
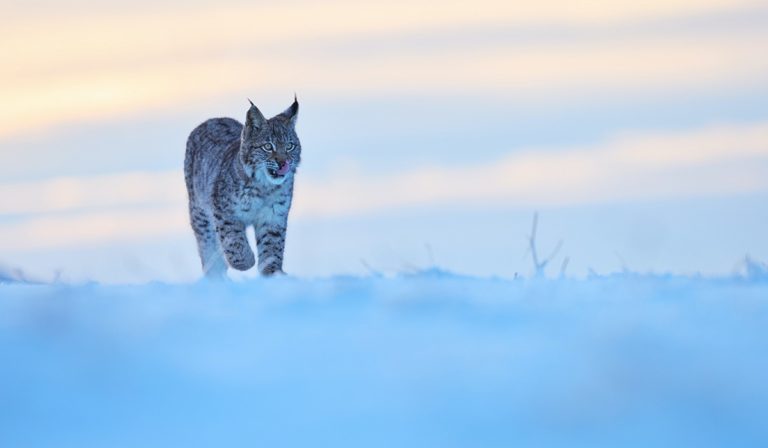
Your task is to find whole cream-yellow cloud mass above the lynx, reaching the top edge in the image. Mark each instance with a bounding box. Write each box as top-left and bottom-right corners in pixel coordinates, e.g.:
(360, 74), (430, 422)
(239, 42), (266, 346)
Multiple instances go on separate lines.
(0, 0), (768, 138)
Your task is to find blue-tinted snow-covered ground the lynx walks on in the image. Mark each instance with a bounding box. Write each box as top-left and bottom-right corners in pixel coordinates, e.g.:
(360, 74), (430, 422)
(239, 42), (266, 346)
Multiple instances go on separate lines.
(0, 270), (768, 447)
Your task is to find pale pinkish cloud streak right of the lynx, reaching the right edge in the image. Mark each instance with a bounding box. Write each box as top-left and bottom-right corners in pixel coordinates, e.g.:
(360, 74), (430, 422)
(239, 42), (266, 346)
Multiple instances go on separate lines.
(296, 123), (768, 216)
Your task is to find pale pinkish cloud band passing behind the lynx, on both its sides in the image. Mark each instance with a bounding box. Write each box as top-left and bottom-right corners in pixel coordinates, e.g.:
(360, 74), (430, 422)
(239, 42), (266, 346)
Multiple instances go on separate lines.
(0, 122), (768, 251)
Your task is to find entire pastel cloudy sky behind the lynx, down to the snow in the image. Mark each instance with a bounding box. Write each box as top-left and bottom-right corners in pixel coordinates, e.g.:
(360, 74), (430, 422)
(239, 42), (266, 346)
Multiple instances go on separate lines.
(0, 0), (768, 283)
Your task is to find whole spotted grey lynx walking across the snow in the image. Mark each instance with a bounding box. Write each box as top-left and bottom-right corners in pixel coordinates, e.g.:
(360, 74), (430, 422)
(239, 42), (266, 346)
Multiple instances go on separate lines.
(184, 99), (301, 278)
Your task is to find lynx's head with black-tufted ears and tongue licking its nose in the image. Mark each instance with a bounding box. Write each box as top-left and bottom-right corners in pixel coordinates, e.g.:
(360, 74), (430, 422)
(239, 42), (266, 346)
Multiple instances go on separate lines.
(240, 98), (301, 185)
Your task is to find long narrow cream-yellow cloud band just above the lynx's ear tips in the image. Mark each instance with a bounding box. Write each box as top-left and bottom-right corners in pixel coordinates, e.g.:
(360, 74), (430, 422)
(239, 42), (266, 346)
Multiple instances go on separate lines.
(6, 33), (768, 139)
